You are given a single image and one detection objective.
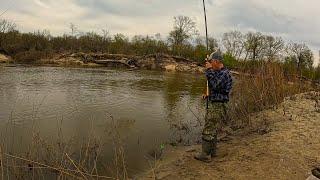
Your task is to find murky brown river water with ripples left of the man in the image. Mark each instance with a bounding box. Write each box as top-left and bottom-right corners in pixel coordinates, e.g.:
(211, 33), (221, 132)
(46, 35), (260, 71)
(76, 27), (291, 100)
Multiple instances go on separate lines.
(0, 67), (205, 174)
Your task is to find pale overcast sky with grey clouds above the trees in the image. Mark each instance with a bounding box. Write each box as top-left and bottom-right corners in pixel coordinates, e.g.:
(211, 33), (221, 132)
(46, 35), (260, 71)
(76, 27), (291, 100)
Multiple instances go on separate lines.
(0, 0), (320, 64)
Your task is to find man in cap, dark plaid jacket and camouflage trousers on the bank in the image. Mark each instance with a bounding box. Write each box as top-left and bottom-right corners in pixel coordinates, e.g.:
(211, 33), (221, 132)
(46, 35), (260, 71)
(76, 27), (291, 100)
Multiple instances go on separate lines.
(195, 51), (232, 162)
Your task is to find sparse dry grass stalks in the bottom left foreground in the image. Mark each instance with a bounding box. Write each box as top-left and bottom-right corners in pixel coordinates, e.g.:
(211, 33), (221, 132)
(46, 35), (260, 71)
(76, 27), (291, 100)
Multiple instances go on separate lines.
(0, 112), (128, 179)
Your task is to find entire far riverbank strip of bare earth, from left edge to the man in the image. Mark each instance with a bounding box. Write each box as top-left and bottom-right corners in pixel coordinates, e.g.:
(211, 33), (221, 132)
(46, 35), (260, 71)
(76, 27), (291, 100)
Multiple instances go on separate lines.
(0, 52), (204, 73)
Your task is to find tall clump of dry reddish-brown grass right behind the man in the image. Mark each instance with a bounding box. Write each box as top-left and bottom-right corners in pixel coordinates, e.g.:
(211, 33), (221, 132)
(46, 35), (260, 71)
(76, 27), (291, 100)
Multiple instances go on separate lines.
(229, 62), (310, 128)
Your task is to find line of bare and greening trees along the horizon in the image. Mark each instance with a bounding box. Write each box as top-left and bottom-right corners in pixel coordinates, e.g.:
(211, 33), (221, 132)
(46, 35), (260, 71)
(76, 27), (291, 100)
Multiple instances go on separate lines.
(0, 16), (320, 79)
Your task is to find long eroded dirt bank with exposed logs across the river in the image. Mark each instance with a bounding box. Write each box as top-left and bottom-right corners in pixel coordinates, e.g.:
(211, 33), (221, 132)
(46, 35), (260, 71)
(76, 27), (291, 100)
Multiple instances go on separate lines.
(54, 53), (203, 72)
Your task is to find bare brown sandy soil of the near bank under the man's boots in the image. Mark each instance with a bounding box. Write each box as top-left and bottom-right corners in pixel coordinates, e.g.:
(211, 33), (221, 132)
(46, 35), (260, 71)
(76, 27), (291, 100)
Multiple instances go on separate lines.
(138, 92), (320, 180)
